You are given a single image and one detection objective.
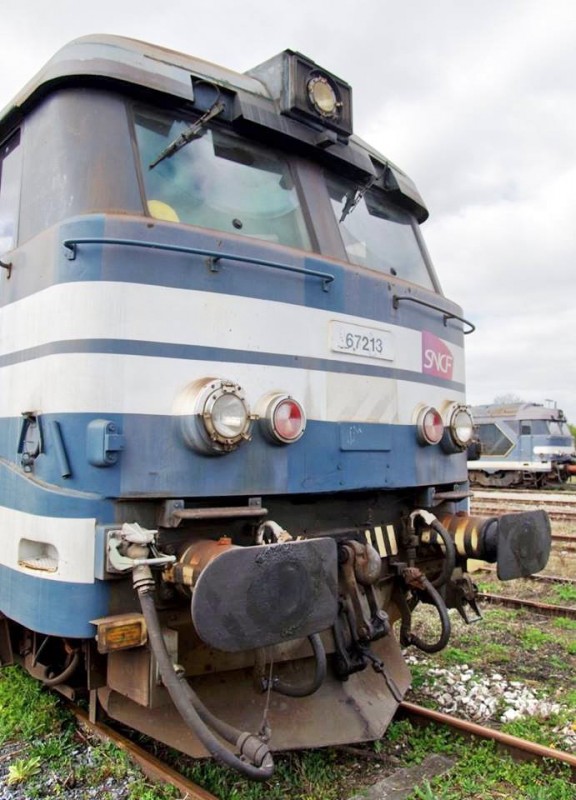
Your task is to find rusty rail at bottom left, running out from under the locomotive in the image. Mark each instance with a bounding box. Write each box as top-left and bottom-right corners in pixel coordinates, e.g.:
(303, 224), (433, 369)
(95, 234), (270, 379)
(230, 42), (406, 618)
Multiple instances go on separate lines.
(70, 706), (219, 800)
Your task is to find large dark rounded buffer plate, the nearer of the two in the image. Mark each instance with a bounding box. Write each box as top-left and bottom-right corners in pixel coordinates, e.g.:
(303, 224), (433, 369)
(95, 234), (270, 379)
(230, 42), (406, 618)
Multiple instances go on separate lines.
(192, 538), (338, 652)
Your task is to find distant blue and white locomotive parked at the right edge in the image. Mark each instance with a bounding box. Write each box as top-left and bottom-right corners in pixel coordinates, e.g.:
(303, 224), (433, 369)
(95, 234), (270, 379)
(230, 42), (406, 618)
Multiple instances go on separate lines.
(468, 402), (576, 489)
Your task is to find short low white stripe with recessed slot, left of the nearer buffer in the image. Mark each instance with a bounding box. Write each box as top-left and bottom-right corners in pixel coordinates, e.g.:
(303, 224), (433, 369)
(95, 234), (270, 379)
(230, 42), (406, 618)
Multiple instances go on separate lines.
(0, 506), (96, 583)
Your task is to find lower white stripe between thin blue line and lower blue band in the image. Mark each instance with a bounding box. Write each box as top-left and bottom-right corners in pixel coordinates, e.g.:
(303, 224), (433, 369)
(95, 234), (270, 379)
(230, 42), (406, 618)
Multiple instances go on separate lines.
(0, 353), (464, 425)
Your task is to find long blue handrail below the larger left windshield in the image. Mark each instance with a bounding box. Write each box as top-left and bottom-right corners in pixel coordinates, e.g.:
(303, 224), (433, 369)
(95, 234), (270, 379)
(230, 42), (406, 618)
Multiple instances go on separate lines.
(62, 237), (334, 292)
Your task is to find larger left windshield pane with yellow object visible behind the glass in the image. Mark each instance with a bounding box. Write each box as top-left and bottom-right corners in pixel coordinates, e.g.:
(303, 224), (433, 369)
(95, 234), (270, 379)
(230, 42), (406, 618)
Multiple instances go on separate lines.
(136, 110), (311, 250)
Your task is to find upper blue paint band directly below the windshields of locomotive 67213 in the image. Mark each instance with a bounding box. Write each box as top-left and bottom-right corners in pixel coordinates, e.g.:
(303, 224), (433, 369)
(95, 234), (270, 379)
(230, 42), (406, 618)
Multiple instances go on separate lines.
(0, 214), (463, 345)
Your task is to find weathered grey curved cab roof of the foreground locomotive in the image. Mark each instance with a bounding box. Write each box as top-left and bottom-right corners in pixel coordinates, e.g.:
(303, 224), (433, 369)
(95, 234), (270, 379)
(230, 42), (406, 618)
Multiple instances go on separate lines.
(0, 34), (428, 222)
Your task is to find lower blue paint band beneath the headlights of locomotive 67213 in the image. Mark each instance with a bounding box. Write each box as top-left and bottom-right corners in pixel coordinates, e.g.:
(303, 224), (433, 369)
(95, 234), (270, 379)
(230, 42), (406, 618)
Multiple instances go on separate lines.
(0, 414), (466, 500)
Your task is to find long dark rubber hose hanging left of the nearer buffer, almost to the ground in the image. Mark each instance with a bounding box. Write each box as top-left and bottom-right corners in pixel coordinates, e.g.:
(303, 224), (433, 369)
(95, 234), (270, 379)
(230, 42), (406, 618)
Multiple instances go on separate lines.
(138, 587), (274, 781)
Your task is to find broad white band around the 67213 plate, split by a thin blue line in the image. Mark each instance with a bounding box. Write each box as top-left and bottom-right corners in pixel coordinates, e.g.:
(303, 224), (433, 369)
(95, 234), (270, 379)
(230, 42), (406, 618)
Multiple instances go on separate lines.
(0, 282), (464, 424)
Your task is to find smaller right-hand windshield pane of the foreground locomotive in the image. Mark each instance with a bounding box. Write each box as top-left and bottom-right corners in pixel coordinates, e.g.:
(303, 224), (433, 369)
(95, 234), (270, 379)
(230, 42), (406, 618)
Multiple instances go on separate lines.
(326, 174), (434, 289)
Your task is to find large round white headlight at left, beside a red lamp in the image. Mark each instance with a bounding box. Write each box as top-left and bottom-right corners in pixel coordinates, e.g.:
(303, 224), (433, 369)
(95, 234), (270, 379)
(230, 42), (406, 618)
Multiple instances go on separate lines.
(175, 378), (252, 455)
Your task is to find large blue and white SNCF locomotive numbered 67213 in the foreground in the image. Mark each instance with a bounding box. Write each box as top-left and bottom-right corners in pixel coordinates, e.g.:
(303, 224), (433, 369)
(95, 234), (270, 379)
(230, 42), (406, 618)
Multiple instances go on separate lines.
(0, 36), (550, 779)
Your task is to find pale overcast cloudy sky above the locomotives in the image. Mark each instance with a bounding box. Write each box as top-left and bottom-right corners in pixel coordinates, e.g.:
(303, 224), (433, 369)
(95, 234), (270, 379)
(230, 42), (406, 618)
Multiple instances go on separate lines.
(0, 0), (576, 424)
